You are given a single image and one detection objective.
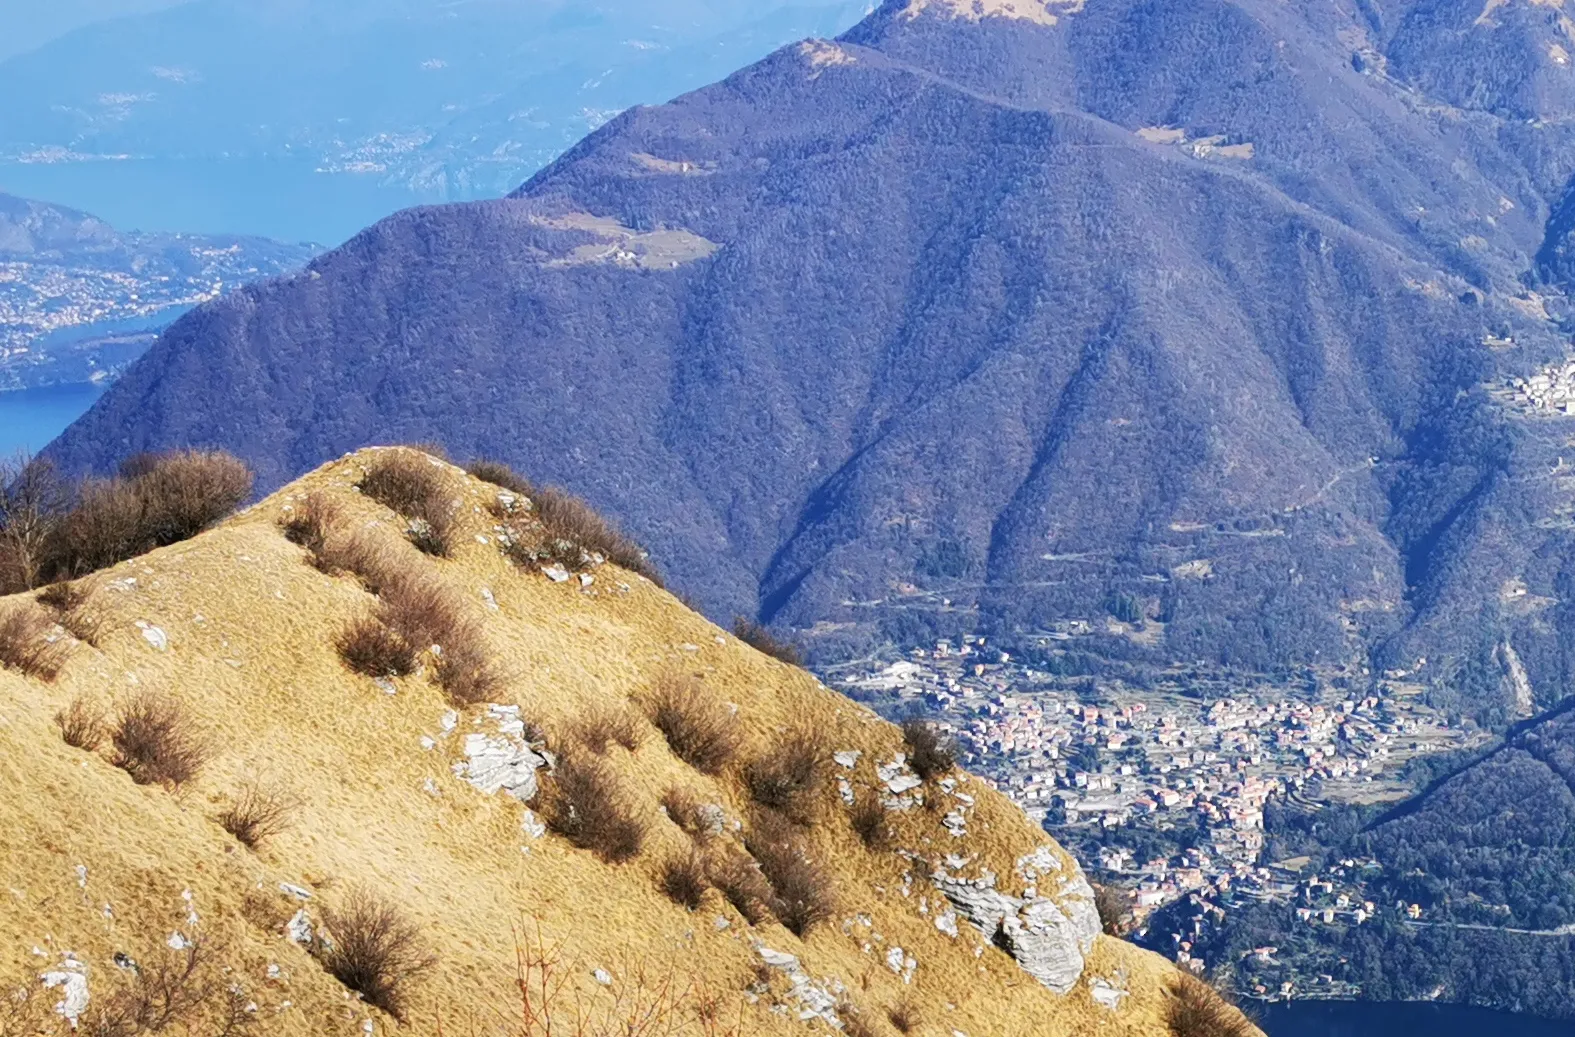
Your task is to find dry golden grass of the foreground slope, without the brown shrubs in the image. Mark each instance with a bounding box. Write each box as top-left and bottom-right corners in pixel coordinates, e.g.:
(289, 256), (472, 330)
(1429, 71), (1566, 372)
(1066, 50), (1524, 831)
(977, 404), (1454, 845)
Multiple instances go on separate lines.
(0, 452), (1241, 1037)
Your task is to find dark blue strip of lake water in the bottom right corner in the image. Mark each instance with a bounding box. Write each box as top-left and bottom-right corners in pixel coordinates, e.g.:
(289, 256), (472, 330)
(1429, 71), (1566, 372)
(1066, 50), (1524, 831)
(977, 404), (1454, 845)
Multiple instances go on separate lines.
(1257, 1001), (1575, 1037)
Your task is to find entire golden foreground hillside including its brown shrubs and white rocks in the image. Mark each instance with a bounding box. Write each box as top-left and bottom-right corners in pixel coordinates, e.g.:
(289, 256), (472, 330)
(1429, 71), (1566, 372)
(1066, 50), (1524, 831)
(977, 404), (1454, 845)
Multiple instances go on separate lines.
(0, 451), (1241, 1037)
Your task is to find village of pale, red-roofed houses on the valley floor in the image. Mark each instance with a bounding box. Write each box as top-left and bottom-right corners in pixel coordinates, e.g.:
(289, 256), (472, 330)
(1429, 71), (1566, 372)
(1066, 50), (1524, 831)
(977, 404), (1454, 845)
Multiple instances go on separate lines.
(825, 637), (1487, 998)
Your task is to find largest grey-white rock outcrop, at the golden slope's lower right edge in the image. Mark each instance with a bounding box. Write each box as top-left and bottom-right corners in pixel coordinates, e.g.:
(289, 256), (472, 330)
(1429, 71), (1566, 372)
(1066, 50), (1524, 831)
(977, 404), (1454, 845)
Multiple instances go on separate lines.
(929, 848), (1099, 994)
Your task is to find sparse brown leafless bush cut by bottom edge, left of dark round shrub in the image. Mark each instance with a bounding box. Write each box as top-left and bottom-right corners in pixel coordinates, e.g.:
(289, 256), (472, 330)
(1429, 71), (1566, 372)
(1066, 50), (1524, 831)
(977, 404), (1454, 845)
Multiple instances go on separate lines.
(80, 933), (260, 1037)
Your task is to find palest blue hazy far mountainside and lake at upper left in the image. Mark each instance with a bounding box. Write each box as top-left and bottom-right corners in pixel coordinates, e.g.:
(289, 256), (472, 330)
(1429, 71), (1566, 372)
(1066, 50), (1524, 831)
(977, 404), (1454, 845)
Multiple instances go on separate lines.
(0, 0), (866, 241)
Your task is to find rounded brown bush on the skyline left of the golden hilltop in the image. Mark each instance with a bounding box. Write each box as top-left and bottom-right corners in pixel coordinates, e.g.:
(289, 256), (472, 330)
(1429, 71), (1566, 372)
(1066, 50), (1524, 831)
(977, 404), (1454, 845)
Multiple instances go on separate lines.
(126, 451), (252, 547)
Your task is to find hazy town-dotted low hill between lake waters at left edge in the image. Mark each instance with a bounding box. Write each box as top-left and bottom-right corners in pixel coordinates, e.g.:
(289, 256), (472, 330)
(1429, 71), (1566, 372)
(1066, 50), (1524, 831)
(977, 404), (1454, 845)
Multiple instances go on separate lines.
(0, 194), (320, 392)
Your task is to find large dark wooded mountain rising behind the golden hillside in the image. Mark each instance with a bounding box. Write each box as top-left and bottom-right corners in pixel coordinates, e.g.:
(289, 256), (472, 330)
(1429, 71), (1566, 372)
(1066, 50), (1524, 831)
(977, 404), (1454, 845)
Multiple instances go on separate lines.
(37, 0), (1575, 711)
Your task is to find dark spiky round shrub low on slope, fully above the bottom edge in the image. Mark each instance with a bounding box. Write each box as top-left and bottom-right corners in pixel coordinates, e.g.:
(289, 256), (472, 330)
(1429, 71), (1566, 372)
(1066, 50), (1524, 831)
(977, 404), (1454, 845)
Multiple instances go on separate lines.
(318, 889), (438, 1023)
